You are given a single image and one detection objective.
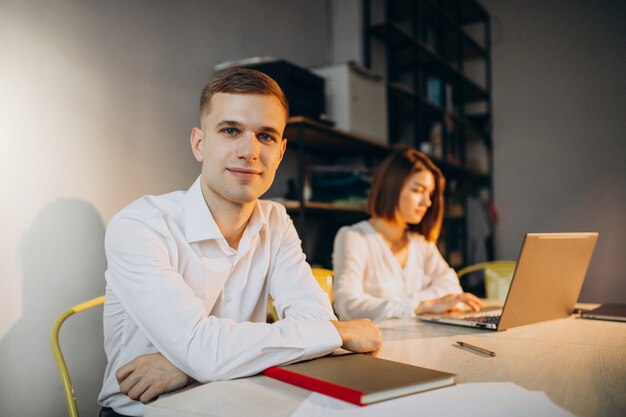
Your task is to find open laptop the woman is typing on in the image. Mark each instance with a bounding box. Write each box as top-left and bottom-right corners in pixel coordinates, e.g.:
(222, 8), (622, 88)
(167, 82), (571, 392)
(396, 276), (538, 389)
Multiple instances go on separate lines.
(419, 233), (598, 331)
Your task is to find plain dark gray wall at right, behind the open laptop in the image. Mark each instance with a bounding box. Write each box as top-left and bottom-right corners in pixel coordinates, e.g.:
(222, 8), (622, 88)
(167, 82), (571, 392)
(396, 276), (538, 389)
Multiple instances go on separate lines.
(481, 0), (626, 302)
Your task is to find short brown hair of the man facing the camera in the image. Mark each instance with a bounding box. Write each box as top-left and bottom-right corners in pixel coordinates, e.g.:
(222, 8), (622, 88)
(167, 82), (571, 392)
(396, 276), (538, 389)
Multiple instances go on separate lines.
(200, 68), (289, 117)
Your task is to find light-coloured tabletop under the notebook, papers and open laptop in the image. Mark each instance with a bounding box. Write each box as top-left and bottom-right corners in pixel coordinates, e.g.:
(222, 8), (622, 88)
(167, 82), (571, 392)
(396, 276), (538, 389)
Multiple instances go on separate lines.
(145, 317), (626, 417)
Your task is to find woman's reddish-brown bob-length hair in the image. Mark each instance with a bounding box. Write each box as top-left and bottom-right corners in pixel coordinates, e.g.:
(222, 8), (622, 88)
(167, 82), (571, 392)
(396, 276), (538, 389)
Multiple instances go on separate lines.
(367, 146), (445, 242)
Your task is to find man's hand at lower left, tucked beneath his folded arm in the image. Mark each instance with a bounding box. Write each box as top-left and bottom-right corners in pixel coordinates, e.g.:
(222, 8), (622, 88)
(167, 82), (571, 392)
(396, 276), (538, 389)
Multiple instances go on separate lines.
(115, 353), (194, 404)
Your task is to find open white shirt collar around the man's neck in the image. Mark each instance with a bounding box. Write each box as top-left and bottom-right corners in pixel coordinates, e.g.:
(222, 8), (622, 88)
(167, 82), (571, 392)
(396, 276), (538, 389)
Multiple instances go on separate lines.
(183, 177), (267, 243)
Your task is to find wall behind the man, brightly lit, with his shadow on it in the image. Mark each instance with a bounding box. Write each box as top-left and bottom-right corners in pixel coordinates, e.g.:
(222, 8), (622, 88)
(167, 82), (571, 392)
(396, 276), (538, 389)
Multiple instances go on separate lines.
(0, 0), (329, 417)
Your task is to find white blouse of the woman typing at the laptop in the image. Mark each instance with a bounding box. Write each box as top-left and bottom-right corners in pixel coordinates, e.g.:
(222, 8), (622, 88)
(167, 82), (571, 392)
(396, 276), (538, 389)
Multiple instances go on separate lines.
(333, 220), (463, 321)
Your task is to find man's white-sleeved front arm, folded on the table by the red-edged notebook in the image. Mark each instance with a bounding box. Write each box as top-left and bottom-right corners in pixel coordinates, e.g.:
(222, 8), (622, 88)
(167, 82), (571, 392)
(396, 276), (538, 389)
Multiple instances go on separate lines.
(106, 218), (342, 382)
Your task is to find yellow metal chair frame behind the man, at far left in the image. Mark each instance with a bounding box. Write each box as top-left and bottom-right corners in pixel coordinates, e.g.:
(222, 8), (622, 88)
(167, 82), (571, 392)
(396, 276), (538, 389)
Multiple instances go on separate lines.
(50, 295), (104, 417)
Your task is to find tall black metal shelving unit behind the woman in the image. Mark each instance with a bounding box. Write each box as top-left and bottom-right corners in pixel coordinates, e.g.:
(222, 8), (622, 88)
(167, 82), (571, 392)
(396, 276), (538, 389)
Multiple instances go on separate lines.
(362, 0), (495, 268)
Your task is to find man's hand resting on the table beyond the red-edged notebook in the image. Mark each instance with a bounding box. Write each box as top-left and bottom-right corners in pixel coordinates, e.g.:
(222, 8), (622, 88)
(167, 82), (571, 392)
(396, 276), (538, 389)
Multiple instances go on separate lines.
(330, 319), (383, 355)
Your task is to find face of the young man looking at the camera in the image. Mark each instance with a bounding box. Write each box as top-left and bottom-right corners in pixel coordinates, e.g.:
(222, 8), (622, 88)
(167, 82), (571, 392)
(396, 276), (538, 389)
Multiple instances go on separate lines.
(191, 93), (287, 205)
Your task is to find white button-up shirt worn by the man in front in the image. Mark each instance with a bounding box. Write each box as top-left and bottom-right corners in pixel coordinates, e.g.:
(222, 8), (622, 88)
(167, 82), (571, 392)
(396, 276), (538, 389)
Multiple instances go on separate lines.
(99, 179), (342, 415)
